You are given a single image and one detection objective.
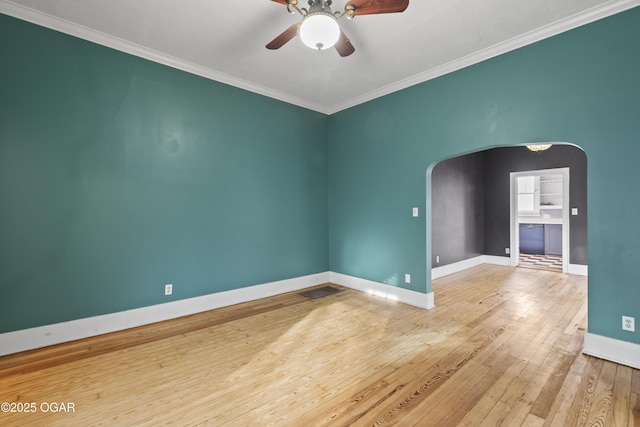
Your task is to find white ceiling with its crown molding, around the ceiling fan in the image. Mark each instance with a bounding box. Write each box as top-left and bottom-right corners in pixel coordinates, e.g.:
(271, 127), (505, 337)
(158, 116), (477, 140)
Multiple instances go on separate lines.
(0, 0), (640, 114)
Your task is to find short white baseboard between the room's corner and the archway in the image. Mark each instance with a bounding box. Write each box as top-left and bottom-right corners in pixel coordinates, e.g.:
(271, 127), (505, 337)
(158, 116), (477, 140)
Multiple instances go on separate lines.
(329, 271), (435, 309)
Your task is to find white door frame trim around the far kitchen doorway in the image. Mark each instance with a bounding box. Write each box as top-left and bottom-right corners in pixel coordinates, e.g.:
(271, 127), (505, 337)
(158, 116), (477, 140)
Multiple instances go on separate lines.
(509, 167), (571, 273)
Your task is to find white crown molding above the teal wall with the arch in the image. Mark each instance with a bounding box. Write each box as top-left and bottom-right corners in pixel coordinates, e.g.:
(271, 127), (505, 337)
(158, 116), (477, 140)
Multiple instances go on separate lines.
(328, 0), (640, 114)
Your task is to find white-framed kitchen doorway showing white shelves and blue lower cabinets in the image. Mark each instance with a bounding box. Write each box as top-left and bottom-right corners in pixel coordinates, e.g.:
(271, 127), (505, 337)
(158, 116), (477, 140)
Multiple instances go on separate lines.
(510, 168), (570, 273)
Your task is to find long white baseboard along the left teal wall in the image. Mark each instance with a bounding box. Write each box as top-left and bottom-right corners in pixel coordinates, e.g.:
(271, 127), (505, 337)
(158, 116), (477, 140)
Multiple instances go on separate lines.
(0, 272), (330, 356)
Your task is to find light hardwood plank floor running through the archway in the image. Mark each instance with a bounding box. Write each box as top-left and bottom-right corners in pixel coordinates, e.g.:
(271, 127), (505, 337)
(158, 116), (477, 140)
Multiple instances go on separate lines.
(0, 265), (640, 427)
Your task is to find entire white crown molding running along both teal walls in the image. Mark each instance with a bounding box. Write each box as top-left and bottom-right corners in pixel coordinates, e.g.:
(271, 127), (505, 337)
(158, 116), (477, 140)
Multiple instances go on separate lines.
(0, 0), (640, 115)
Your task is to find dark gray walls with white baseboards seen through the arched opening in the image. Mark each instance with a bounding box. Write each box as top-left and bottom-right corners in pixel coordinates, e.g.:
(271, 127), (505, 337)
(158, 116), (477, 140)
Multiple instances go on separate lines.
(426, 143), (587, 297)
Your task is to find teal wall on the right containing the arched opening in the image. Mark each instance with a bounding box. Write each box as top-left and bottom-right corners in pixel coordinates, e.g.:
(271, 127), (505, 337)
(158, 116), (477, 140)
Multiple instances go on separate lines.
(329, 8), (640, 343)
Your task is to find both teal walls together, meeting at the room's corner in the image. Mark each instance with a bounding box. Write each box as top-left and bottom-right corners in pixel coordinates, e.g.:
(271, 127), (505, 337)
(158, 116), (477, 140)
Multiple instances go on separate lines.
(0, 8), (640, 343)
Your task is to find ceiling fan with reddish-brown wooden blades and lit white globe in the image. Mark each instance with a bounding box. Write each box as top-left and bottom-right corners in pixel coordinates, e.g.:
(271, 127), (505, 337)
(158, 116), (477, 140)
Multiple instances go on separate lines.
(267, 0), (409, 57)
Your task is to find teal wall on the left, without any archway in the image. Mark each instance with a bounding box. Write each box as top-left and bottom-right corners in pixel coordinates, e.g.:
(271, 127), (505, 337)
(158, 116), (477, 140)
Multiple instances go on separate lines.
(0, 15), (329, 332)
